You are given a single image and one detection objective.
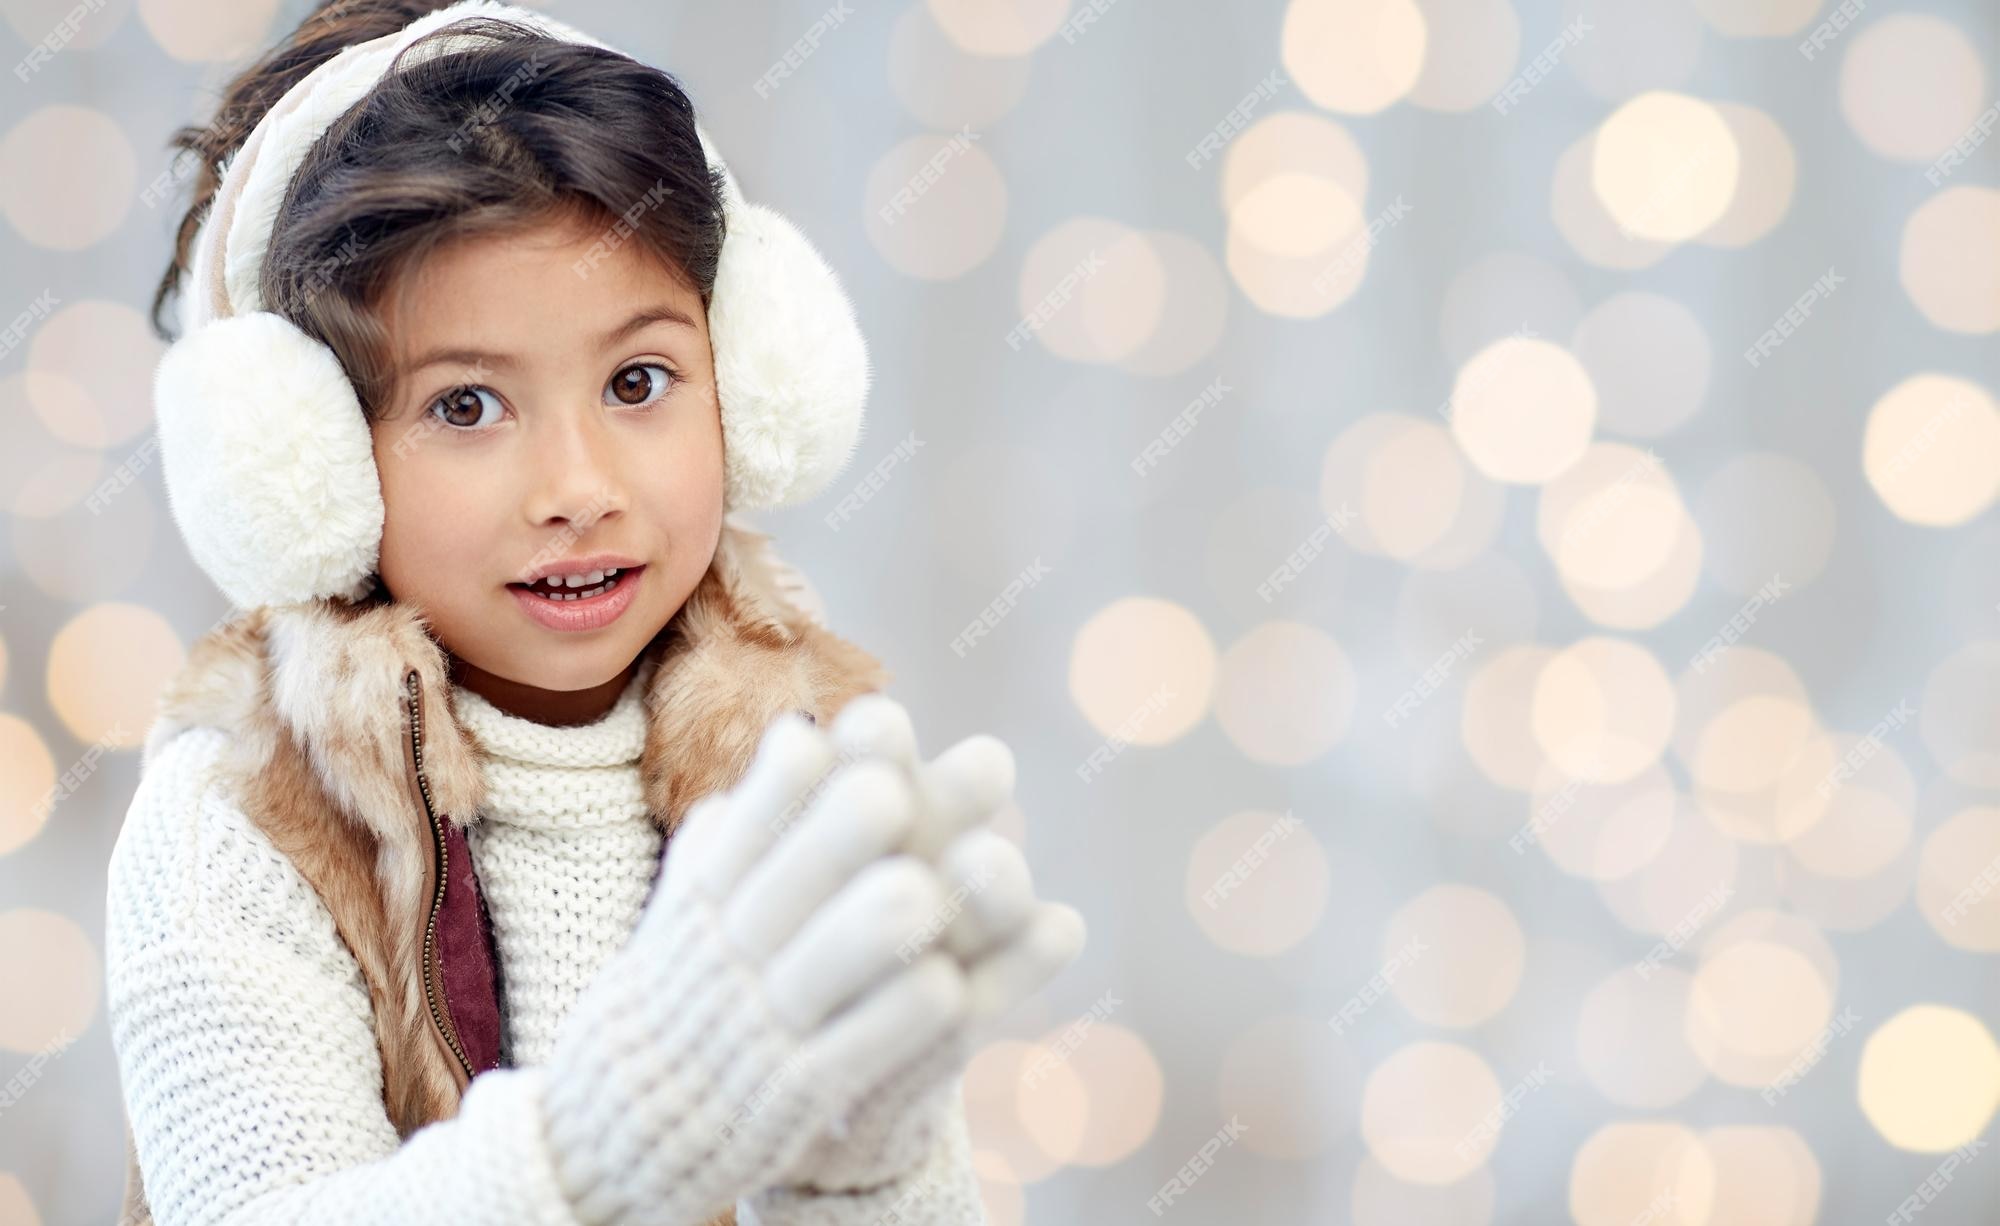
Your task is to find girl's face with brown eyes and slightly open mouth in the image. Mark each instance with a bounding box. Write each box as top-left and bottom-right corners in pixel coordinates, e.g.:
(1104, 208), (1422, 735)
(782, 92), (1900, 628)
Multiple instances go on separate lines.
(372, 220), (722, 722)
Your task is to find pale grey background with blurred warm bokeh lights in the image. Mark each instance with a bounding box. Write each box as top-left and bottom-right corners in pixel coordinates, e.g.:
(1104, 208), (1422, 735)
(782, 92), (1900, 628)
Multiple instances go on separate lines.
(0, 0), (2000, 1226)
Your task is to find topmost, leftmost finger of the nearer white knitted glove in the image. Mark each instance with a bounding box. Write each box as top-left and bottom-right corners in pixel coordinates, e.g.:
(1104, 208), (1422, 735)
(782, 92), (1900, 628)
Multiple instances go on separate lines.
(678, 712), (834, 898)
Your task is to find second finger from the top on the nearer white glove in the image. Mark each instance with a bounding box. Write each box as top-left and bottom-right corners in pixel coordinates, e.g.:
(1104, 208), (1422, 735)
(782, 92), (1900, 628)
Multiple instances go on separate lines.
(724, 760), (916, 962)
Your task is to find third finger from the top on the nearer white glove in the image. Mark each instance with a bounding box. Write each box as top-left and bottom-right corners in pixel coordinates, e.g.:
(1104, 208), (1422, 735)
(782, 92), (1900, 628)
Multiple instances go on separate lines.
(764, 856), (944, 1030)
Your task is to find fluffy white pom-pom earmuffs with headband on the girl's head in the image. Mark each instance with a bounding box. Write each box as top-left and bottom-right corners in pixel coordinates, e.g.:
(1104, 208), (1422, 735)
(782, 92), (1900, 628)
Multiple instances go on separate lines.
(154, 0), (870, 608)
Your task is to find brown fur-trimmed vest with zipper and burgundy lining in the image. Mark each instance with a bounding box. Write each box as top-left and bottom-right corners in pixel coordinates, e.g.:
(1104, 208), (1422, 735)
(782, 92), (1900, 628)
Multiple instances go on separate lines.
(118, 522), (888, 1226)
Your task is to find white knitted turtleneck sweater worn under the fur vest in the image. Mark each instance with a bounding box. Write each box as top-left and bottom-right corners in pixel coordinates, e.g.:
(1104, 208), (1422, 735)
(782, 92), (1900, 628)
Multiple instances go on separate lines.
(106, 670), (984, 1226)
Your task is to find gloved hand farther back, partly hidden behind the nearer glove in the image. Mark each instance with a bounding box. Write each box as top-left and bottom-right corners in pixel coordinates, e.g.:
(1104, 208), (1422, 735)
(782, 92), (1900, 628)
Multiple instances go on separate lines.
(760, 694), (1084, 1190)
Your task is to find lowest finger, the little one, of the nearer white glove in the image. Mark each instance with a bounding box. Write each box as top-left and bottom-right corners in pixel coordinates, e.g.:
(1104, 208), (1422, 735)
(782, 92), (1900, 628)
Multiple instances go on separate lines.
(804, 952), (966, 1114)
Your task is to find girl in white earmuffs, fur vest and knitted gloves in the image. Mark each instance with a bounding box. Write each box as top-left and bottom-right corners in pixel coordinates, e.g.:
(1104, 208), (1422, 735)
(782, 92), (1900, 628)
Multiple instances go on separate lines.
(106, 0), (1082, 1226)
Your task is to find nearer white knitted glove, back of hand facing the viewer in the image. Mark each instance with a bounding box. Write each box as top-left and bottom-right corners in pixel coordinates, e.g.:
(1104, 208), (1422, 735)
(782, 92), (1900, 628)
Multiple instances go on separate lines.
(544, 714), (968, 1226)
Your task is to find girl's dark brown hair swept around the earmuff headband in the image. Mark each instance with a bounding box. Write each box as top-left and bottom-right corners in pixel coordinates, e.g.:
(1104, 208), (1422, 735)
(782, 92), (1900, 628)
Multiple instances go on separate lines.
(152, 0), (724, 416)
